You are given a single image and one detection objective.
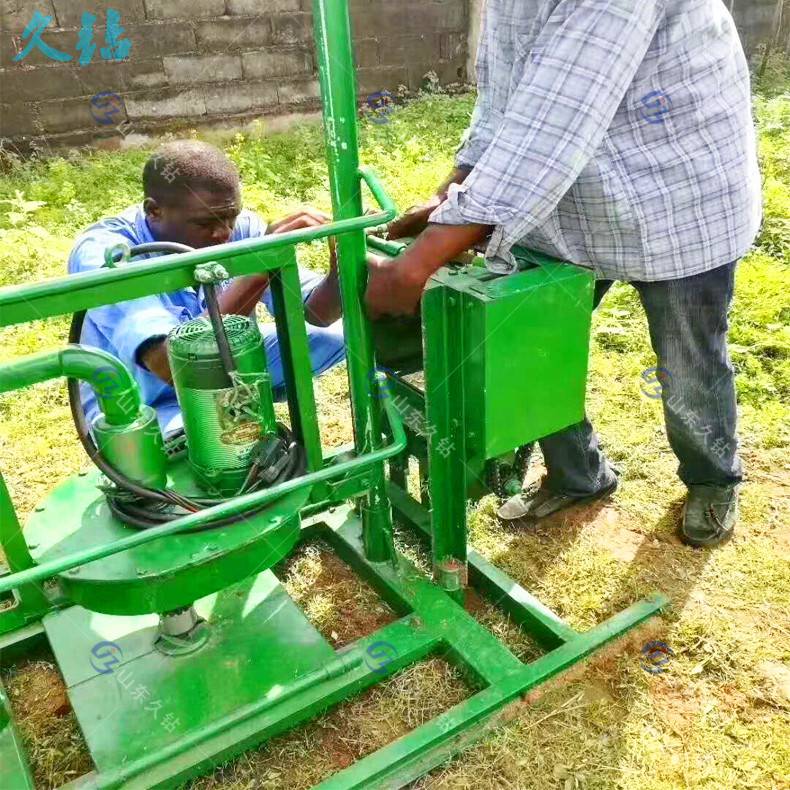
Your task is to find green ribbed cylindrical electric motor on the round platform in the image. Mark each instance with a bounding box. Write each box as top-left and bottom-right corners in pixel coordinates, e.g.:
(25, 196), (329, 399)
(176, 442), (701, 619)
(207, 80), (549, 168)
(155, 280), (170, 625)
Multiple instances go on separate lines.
(167, 315), (277, 496)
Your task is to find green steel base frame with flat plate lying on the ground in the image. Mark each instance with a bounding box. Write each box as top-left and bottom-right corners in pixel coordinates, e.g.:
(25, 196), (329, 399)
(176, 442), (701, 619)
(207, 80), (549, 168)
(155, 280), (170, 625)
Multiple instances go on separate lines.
(0, 508), (667, 790)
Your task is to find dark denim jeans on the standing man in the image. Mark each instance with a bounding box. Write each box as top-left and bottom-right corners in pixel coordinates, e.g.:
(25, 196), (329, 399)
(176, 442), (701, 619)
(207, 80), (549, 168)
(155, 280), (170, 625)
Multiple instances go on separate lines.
(540, 263), (742, 496)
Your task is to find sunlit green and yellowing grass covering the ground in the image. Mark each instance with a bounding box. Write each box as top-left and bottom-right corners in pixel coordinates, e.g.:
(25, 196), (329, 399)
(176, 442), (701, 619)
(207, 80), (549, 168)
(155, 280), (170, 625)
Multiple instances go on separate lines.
(0, 67), (790, 790)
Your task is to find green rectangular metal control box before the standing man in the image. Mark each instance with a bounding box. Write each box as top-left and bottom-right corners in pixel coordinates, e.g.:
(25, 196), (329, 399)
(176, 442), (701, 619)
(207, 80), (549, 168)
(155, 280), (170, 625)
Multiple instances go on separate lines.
(423, 249), (594, 476)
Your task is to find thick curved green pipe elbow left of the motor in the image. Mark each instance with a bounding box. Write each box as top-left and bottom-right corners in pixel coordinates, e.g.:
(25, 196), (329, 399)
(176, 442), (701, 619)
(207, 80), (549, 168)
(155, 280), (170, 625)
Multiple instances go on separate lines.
(0, 345), (143, 425)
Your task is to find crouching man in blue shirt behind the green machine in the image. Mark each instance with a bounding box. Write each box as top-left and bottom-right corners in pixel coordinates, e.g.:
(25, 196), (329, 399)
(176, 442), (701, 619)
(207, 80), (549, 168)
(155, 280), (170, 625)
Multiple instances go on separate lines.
(68, 140), (345, 434)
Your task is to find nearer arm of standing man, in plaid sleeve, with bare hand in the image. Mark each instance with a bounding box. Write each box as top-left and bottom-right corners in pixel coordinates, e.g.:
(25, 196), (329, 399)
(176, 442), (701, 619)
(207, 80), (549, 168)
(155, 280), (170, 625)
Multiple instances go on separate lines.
(367, 0), (663, 315)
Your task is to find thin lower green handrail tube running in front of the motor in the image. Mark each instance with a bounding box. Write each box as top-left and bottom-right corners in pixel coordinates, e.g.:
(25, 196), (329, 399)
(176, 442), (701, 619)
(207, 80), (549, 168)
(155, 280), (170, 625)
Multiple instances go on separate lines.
(0, 374), (406, 593)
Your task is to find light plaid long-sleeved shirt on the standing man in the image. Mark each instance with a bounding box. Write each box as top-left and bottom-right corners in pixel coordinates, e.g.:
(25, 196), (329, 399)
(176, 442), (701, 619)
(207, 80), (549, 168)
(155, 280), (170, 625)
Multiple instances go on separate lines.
(431, 0), (761, 281)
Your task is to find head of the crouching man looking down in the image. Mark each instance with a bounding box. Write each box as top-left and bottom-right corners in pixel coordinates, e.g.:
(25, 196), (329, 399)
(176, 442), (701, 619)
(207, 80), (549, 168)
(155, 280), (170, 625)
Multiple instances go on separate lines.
(143, 140), (241, 248)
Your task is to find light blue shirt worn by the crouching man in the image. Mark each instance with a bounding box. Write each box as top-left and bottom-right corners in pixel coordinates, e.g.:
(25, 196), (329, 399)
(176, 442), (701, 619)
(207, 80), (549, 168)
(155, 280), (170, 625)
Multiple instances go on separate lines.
(68, 205), (345, 433)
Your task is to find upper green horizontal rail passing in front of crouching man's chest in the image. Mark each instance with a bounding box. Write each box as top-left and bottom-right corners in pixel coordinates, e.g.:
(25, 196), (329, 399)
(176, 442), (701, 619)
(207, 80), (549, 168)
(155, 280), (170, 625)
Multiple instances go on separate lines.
(0, 206), (396, 326)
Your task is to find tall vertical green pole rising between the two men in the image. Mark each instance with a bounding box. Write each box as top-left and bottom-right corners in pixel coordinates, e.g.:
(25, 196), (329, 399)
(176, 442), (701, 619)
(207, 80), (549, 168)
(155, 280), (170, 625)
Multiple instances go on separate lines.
(313, 0), (394, 562)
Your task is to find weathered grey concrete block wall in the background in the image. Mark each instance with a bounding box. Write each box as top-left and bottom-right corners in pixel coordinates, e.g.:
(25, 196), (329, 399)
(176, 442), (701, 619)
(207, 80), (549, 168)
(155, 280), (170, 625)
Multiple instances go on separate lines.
(0, 0), (468, 145)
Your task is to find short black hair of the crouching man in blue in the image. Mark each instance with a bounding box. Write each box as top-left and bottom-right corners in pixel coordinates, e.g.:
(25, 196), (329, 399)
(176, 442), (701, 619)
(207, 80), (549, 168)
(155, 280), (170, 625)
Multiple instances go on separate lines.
(143, 140), (239, 203)
